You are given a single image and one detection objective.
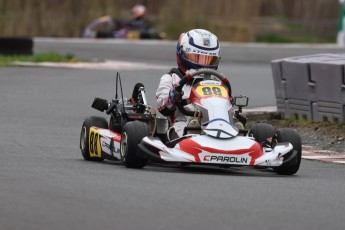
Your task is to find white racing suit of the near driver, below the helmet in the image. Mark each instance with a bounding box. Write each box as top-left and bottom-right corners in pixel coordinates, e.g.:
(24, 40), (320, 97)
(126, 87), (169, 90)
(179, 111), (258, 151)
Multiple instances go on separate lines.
(156, 68), (192, 140)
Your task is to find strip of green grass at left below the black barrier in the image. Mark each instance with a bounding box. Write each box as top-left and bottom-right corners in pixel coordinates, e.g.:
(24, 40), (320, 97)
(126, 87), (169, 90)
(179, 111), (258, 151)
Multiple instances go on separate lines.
(0, 52), (79, 66)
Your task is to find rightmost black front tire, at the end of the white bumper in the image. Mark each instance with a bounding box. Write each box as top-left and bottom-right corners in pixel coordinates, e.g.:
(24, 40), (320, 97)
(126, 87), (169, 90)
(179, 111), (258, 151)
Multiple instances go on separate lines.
(272, 128), (302, 175)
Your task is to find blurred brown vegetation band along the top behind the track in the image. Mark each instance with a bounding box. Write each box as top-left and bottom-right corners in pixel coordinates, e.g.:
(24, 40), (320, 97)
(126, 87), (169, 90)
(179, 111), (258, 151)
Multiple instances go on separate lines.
(0, 0), (341, 43)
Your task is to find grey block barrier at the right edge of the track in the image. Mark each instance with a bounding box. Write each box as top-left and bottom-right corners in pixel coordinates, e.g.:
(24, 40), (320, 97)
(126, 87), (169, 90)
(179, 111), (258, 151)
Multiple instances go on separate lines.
(271, 54), (345, 122)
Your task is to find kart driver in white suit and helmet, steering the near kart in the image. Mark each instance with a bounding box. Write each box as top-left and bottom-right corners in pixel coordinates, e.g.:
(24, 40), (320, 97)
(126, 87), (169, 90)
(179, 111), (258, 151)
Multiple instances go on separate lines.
(156, 29), (220, 141)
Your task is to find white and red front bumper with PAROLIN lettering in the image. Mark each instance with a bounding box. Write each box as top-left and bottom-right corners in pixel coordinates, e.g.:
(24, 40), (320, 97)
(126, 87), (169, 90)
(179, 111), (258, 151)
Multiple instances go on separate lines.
(142, 135), (292, 166)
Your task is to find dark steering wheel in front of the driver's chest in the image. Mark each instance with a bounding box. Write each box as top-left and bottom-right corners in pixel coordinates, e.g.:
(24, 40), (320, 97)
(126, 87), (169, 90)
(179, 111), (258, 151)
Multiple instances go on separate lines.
(175, 69), (231, 116)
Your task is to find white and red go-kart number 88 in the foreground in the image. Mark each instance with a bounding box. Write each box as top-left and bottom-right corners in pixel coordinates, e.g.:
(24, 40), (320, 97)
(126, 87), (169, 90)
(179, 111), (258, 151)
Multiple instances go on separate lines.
(80, 69), (302, 175)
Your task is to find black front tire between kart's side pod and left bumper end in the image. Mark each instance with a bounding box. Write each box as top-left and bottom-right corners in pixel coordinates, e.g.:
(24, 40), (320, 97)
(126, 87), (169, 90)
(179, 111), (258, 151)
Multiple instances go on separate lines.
(120, 121), (149, 168)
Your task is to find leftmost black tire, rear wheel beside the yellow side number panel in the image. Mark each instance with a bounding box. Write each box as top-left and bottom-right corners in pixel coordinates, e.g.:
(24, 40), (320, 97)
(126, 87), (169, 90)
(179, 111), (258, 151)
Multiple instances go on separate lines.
(79, 116), (108, 161)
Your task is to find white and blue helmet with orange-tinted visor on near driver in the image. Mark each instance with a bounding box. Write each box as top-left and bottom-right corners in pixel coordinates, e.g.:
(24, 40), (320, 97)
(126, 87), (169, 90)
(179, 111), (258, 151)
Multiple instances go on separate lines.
(176, 29), (220, 72)
